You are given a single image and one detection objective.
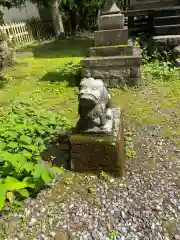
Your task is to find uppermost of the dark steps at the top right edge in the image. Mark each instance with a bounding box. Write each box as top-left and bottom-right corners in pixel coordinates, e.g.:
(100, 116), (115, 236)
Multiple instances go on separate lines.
(154, 6), (180, 17)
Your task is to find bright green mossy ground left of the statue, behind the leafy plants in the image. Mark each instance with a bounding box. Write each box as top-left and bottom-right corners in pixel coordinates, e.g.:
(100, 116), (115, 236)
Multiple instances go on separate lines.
(0, 40), (91, 124)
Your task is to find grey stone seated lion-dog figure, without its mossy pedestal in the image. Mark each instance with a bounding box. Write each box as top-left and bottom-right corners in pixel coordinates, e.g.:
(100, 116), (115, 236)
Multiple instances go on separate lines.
(78, 77), (112, 132)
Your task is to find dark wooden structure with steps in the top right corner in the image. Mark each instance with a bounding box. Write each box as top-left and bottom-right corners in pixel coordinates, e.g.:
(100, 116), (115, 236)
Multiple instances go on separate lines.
(123, 0), (180, 35)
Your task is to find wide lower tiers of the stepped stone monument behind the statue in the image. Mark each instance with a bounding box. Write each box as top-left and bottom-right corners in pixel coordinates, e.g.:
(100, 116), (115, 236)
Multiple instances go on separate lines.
(81, 45), (142, 87)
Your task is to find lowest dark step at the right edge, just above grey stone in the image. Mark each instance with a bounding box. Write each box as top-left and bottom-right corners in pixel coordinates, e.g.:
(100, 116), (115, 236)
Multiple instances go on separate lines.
(154, 24), (180, 36)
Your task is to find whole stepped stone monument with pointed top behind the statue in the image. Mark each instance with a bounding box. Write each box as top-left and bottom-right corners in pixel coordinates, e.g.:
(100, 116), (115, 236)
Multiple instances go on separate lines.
(81, 3), (141, 87)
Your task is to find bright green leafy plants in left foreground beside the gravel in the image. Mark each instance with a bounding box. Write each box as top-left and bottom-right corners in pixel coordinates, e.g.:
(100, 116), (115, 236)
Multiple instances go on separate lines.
(0, 103), (69, 210)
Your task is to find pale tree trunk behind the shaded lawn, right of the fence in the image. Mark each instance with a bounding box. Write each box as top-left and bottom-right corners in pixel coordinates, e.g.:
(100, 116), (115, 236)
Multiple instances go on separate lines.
(51, 0), (65, 38)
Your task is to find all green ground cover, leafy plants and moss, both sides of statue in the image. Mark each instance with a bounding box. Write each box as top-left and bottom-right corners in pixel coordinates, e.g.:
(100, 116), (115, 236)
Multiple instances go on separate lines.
(0, 34), (180, 221)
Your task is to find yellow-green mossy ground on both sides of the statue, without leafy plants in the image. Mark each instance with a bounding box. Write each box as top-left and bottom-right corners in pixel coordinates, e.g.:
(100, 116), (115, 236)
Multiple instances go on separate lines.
(0, 40), (180, 144)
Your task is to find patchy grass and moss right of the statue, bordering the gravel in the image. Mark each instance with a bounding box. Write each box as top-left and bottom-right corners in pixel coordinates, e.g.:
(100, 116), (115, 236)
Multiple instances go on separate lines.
(113, 62), (180, 144)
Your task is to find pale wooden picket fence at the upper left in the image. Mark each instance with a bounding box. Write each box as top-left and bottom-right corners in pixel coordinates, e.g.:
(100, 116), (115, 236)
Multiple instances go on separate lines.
(0, 22), (34, 48)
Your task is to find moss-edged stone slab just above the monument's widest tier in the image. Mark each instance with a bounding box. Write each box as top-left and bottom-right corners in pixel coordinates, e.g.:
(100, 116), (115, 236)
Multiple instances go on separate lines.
(89, 40), (133, 57)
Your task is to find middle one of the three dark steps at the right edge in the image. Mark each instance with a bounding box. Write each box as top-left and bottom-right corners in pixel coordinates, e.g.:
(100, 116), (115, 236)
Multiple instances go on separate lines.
(154, 15), (180, 26)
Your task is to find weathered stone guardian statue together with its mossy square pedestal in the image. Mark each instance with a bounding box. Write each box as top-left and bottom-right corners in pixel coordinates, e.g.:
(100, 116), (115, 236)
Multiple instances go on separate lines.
(70, 74), (124, 176)
